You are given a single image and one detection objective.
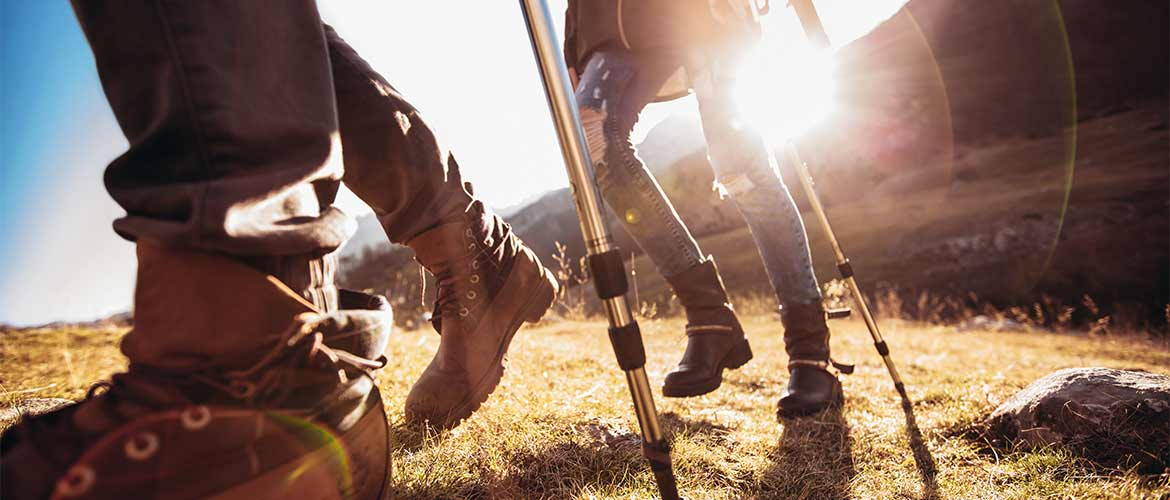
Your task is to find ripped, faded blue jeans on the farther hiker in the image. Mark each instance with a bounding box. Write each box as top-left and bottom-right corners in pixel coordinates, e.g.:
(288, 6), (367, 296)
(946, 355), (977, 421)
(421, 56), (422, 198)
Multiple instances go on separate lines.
(577, 50), (821, 306)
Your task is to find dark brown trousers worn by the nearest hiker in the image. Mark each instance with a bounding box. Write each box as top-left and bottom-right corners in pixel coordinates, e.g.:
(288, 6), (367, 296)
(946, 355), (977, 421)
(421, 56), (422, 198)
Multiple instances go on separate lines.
(74, 0), (472, 255)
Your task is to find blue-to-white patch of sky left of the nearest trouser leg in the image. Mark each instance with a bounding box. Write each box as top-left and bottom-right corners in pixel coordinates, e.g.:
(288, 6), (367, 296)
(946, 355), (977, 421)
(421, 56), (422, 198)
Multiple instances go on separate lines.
(0, 0), (133, 323)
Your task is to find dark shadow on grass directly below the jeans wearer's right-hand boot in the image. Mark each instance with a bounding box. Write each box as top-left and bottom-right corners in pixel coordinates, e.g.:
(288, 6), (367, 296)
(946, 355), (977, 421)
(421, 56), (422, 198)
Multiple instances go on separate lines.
(758, 409), (856, 499)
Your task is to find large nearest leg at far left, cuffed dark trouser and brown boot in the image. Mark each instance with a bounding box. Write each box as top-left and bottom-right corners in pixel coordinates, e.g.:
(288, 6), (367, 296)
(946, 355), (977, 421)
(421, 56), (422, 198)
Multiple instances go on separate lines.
(0, 0), (390, 498)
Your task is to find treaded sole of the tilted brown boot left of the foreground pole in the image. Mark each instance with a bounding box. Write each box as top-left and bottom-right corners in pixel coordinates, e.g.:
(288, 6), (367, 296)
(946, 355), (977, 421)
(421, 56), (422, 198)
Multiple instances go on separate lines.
(441, 259), (559, 429)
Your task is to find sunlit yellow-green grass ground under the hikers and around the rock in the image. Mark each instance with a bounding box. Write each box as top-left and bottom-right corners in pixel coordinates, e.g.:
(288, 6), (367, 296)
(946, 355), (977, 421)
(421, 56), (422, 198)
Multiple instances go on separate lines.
(0, 315), (1170, 499)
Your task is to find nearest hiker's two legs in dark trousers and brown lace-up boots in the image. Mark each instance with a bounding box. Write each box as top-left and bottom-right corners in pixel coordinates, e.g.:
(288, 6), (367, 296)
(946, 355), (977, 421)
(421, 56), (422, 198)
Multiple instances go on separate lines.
(0, 0), (556, 498)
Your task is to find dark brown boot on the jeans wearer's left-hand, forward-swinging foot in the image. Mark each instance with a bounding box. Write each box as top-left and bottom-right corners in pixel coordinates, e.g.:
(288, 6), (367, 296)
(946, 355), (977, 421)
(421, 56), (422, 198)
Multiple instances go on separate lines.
(662, 258), (751, 397)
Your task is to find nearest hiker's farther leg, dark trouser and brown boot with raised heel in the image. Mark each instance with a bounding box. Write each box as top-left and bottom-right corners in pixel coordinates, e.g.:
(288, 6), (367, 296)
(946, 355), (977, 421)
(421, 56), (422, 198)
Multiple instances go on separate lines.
(325, 27), (557, 427)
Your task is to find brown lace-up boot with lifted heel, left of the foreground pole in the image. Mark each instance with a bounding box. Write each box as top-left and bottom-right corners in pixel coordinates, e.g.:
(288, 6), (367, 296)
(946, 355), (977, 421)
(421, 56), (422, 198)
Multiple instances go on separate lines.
(406, 201), (558, 429)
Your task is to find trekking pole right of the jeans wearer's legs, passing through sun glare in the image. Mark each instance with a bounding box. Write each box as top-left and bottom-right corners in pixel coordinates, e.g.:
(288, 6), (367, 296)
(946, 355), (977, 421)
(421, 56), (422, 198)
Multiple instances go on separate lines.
(784, 0), (910, 407)
